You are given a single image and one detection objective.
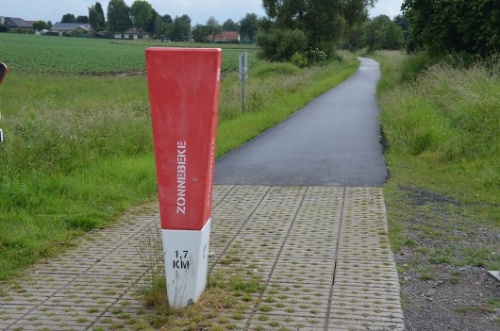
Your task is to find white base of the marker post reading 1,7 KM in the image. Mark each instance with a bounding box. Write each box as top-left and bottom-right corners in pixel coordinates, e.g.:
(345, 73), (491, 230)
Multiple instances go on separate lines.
(162, 219), (211, 308)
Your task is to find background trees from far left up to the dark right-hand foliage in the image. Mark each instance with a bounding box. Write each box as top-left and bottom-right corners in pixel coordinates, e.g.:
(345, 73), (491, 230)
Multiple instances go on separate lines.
(28, 0), (408, 63)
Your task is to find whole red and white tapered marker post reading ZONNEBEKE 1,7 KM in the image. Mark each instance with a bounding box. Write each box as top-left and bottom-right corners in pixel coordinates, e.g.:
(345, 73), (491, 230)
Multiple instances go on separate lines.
(146, 47), (222, 308)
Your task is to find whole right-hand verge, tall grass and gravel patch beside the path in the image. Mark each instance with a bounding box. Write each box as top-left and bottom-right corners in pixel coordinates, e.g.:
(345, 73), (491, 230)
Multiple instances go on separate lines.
(374, 52), (500, 329)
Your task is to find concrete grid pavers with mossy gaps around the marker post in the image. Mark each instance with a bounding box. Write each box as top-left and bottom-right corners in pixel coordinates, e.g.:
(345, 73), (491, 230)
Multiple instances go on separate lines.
(0, 185), (404, 331)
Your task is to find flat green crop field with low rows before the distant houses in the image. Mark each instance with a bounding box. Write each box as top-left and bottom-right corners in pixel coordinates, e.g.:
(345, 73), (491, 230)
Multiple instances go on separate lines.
(0, 33), (257, 75)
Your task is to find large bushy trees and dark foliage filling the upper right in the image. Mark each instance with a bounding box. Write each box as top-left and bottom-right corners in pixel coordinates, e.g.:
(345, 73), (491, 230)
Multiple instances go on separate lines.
(257, 0), (500, 66)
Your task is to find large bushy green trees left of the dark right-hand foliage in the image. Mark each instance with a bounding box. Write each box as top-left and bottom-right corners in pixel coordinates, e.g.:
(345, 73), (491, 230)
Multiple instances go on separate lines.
(257, 0), (405, 64)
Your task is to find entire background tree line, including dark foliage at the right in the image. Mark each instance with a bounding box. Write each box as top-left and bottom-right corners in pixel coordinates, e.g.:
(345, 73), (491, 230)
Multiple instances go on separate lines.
(27, 0), (500, 66)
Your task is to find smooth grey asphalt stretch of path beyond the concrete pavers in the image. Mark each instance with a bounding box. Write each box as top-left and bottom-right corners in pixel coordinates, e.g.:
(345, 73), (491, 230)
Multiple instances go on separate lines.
(215, 58), (387, 186)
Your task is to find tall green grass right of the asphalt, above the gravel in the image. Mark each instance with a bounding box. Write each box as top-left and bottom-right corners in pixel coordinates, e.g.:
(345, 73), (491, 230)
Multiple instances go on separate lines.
(379, 55), (500, 205)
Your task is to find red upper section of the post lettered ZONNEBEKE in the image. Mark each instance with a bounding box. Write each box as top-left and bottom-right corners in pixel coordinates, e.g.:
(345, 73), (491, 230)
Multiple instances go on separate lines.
(146, 48), (222, 230)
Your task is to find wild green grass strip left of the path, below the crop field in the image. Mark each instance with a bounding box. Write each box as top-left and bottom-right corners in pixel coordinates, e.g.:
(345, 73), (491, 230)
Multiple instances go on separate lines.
(0, 57), (357, 281)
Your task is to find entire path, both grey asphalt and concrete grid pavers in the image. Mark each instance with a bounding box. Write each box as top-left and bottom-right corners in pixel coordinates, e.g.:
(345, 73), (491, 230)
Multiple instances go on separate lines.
(0, 59), (404, 331)
